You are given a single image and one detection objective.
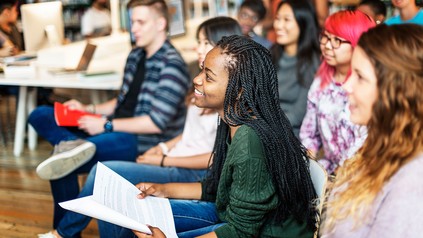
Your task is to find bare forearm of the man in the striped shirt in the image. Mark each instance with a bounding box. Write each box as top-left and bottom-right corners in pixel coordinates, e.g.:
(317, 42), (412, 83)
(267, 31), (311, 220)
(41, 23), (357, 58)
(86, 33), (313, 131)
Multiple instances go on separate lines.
(113, 116), (162, 134)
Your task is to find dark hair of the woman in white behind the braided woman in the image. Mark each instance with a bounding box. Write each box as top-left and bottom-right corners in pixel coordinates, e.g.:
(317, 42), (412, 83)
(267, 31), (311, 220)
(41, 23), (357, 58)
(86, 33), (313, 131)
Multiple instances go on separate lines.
(196, 16), (242, 46)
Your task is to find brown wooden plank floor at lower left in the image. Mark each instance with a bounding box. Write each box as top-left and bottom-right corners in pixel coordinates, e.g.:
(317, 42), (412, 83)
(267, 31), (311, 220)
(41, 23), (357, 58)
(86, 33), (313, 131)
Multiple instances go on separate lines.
(0, 97), (98, 238)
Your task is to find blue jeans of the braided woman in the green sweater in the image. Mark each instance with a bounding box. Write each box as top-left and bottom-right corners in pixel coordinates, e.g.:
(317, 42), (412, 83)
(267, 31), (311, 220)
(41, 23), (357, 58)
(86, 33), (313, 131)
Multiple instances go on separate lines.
(98, 199), (226, 238)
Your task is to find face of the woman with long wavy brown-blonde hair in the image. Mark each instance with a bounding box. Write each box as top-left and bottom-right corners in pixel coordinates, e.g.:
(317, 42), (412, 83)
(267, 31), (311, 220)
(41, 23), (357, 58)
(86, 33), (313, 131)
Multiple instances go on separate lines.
(343, 47), (378, 125)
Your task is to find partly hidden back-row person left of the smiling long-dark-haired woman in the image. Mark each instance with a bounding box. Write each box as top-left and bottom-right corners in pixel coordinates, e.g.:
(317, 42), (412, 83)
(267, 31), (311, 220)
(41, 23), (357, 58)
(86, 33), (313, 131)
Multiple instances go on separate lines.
(238, 0), (272, 49)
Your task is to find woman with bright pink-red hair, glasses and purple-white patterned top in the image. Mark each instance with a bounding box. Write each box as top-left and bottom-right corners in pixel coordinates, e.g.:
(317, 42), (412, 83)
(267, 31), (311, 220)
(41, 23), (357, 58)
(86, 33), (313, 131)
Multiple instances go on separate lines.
(300, 10), (375, 174)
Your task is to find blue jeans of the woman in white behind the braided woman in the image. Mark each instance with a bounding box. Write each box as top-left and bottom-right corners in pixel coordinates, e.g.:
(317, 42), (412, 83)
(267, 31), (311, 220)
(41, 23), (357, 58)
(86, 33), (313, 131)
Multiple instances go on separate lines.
(57, 161), (206, 237)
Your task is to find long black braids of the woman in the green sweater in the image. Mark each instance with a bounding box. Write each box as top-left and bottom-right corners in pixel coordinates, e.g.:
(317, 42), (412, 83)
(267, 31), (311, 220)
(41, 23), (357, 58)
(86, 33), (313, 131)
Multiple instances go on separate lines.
(205, 36), (317, 228)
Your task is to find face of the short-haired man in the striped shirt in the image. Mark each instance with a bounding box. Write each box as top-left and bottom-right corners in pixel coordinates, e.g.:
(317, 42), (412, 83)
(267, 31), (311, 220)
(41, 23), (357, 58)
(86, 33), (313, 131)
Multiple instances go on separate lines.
(131, 6), (166, 51)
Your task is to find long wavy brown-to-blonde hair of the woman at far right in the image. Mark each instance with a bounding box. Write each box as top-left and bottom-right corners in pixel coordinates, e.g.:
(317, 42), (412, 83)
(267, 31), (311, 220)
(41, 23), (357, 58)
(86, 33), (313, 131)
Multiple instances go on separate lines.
(322, 24), (423, 233)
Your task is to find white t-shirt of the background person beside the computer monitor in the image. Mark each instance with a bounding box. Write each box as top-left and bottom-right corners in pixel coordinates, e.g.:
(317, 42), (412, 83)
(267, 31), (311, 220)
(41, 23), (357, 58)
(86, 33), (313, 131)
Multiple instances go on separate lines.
(81, 7), (111, 36)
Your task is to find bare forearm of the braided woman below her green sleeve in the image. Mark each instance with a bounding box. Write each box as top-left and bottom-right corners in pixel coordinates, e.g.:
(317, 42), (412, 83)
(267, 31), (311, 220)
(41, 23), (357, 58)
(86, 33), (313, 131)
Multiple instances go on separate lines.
(164, 183), (201, 200)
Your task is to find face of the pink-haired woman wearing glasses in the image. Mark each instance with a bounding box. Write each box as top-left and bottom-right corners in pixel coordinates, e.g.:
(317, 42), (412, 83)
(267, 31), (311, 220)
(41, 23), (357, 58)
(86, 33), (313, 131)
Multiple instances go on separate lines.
(320, 31), (353, 67)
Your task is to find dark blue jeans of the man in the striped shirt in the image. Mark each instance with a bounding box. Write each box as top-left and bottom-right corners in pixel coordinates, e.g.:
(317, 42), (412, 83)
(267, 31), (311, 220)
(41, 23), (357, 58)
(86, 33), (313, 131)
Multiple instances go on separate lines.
(28, 106), (138, 231)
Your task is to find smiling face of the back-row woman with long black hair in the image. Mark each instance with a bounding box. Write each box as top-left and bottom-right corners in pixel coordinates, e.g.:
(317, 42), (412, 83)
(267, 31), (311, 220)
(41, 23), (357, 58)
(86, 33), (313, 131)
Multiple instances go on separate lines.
(273, 4), (300, 54)
